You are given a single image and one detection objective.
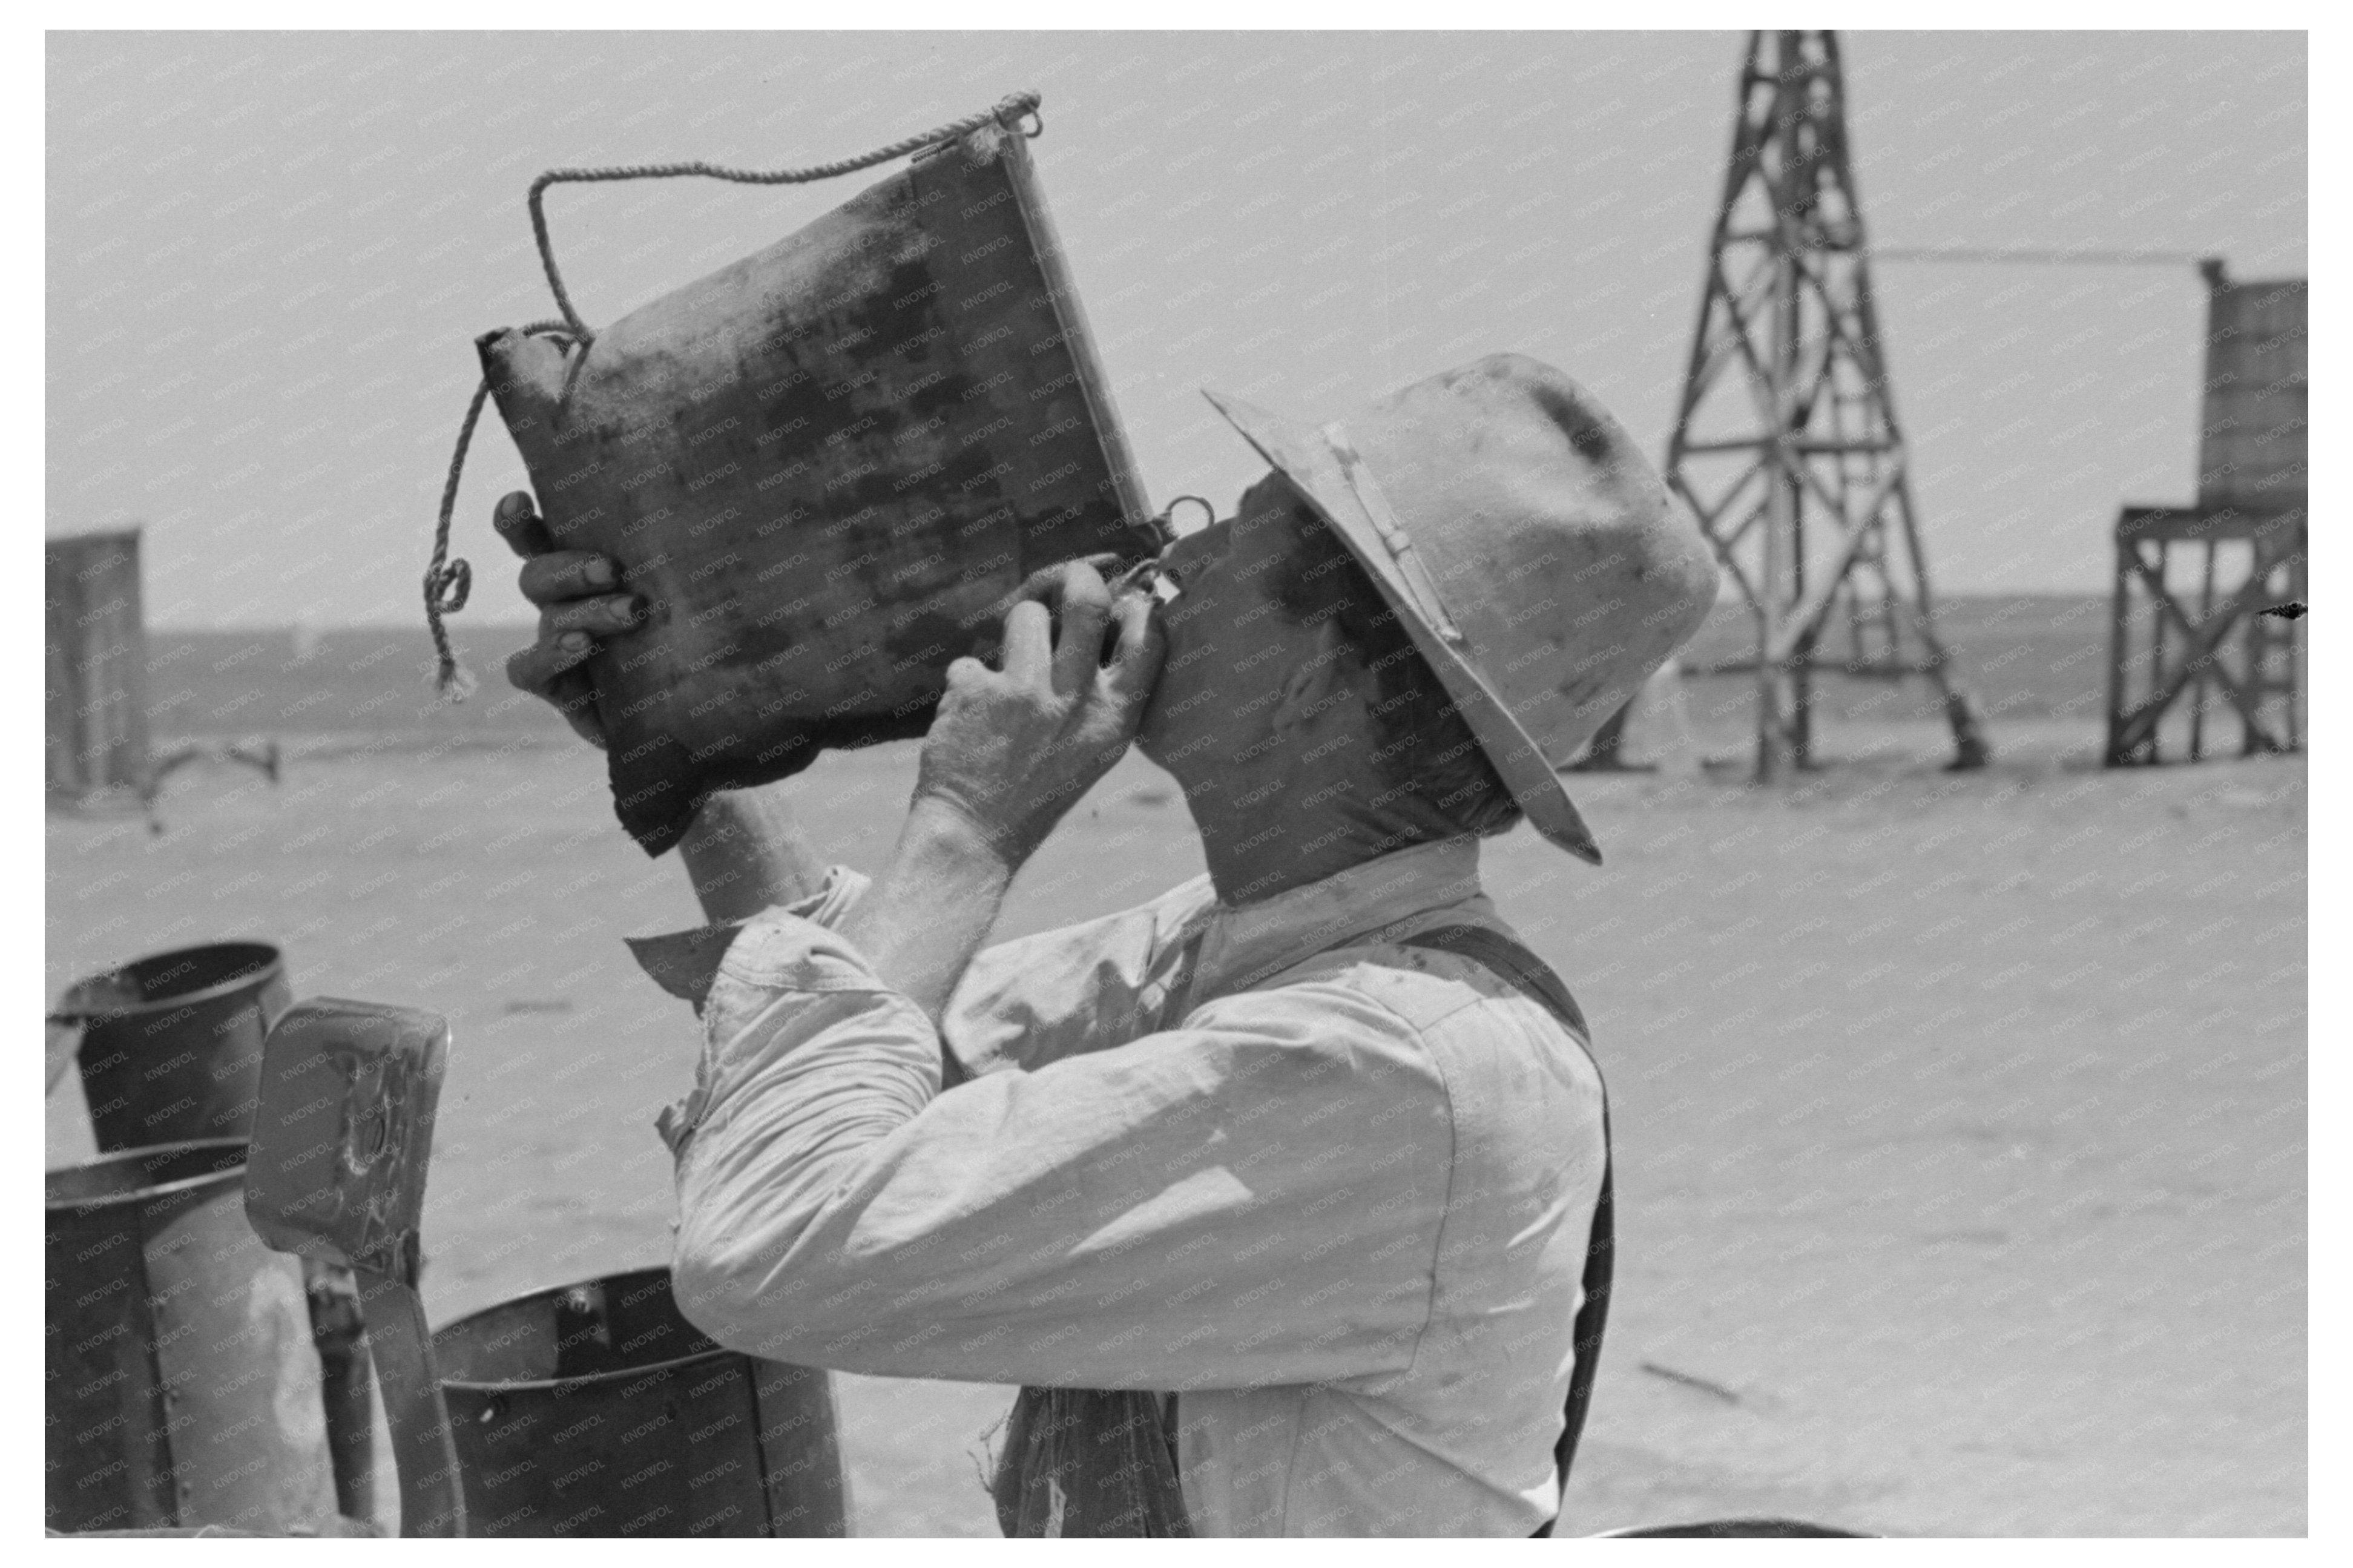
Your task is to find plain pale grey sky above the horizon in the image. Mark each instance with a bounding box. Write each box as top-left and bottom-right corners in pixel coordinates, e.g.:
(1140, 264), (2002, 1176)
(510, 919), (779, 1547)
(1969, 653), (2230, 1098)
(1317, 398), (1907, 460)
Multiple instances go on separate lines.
(45, 33), (2308, 638)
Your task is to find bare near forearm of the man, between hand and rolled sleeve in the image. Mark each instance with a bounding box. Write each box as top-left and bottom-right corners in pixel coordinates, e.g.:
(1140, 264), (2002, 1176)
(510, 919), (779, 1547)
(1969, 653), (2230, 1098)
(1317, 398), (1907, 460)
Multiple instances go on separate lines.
(843, 798), (1014, 1024)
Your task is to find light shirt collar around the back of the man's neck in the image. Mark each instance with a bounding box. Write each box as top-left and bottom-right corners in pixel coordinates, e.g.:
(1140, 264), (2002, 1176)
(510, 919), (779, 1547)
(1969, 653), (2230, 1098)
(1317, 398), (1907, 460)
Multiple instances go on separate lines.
(1193, 836), (1480, 998)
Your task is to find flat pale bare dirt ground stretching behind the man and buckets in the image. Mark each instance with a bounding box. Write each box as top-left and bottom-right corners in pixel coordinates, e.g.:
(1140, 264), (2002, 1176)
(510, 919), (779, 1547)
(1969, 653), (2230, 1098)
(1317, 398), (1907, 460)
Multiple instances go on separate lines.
(47, 709), (2306, 1535)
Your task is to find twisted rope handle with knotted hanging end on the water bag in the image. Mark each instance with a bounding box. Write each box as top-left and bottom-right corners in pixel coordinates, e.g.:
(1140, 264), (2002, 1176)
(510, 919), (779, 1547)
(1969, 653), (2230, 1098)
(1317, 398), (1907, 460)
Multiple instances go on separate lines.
(426, 92), (1045, 702)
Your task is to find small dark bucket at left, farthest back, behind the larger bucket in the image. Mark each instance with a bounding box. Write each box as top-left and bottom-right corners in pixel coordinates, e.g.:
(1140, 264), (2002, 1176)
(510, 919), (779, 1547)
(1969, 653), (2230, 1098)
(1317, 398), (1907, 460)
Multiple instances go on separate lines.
(52, 942), (294, 1151)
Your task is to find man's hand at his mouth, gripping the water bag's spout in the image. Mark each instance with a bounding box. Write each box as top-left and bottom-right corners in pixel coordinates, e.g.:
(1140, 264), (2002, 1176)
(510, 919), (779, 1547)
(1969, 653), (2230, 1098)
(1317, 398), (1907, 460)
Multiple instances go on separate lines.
(915, 561), (1167, 871)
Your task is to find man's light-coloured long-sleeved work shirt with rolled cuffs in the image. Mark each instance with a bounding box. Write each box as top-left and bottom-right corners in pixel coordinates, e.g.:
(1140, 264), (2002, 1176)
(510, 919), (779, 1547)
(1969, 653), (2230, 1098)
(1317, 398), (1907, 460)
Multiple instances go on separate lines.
(633, 838), (1605, 1537)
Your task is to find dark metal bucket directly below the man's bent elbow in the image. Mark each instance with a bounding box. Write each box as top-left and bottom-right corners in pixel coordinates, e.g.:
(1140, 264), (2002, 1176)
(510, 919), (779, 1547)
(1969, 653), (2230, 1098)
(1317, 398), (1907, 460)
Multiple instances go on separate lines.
(433, 1269), (849, 1535)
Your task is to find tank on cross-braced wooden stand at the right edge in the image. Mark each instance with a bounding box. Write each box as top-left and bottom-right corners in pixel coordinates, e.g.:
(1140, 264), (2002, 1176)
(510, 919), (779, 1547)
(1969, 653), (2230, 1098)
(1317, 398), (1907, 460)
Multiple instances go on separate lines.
(2106, 262), (2308, 768)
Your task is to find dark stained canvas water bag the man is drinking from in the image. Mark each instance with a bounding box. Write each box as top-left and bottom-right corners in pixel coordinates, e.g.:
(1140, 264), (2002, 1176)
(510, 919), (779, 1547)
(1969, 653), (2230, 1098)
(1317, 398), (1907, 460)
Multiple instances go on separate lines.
(466, 99), (1157, 855)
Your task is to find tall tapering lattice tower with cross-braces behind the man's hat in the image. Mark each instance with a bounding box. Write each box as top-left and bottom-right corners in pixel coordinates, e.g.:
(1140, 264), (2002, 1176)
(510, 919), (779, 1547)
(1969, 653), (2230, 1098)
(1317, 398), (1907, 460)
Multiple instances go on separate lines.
(1666, 33), (1989, 779)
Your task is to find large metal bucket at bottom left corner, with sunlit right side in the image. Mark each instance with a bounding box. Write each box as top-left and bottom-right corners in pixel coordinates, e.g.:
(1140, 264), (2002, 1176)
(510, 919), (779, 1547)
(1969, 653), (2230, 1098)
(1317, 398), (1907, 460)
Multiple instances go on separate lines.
(42, 1137), (337, 1533)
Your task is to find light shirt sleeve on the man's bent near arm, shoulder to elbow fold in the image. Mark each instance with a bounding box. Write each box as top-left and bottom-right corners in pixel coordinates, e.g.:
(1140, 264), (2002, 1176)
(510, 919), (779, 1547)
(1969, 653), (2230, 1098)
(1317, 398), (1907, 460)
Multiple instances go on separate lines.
(654, 911), (1452, 1389)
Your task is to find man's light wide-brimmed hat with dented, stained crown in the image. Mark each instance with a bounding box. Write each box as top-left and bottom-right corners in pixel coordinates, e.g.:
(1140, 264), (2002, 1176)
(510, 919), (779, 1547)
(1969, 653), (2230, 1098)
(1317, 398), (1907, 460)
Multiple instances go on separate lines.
(1205, 353), (1718, 864)
